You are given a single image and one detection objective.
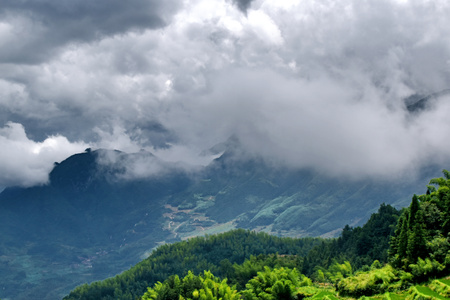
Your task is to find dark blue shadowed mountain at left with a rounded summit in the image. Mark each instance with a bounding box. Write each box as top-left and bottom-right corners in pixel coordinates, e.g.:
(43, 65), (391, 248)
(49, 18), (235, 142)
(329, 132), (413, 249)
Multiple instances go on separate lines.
(0, 150), (190, 299)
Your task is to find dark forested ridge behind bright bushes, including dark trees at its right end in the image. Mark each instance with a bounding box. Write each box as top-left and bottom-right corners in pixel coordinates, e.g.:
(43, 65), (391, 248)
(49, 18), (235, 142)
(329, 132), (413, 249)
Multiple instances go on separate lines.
(65, 204), (399, 299)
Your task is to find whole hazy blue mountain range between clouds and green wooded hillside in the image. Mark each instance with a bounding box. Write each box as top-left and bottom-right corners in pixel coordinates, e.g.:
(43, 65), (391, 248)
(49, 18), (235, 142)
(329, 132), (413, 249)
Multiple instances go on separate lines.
(0, 144), (440, 299)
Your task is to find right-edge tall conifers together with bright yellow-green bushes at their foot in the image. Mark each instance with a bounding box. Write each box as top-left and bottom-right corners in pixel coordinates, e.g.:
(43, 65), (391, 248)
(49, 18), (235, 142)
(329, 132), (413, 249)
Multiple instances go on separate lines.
(335, 170), (450, 299)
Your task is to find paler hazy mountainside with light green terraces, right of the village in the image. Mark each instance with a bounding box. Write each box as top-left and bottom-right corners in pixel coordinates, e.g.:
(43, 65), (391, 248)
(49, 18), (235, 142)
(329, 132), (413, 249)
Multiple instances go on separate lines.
(172, 146), (432, 236)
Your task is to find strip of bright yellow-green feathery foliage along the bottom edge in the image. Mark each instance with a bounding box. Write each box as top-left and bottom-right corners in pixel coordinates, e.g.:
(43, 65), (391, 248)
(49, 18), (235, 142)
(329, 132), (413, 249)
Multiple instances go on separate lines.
(141, 265), (450, 300)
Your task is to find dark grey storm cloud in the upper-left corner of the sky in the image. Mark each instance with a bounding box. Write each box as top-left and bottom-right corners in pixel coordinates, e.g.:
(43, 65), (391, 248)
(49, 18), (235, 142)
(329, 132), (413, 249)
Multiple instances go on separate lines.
(0, 0), (180, 63)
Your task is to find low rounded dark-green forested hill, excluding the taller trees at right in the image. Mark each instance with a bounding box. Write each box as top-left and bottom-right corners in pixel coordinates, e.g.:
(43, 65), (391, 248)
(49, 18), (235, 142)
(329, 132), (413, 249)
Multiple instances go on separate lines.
(64, 229), (322, 300)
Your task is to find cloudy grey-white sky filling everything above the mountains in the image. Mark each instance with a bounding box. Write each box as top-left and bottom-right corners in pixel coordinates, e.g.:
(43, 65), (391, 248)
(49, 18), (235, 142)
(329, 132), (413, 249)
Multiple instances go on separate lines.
(0, 0), (450, 187)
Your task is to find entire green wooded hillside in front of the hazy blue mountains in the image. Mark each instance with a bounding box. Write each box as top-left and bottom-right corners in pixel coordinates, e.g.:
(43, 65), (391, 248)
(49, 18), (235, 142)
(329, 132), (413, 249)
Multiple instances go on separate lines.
(64, 170), (450, 300)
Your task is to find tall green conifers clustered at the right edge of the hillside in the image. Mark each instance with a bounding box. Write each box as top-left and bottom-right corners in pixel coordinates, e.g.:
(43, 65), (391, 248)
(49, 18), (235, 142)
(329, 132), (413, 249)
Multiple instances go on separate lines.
(390, 170), (450, 281)
